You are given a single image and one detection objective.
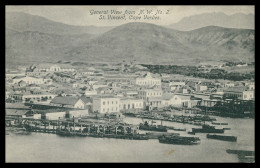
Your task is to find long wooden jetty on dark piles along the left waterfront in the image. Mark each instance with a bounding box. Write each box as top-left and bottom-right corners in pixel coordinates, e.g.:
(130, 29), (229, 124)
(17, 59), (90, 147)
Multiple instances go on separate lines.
(6, 118), (148, 140)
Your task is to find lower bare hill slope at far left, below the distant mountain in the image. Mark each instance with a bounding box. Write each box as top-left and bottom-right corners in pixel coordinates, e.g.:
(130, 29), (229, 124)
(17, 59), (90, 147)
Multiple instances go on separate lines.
(5, 29), (94, 64)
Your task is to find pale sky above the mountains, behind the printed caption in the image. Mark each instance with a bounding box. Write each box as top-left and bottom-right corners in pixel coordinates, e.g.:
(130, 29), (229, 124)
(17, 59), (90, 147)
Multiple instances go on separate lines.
(6, 5), (255, 26)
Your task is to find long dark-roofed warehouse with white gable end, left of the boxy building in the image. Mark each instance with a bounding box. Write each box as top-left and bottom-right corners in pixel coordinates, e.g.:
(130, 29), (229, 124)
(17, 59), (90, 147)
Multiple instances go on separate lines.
(50, 96), (85, 109)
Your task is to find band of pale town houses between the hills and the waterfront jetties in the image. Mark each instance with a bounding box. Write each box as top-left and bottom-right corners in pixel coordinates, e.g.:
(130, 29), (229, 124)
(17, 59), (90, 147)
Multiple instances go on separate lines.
(6, 64), (255, 119)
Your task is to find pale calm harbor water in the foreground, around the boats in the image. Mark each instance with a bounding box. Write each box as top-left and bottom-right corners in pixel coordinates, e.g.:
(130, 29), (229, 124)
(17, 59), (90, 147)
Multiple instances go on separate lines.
(5, 117), (255, 162)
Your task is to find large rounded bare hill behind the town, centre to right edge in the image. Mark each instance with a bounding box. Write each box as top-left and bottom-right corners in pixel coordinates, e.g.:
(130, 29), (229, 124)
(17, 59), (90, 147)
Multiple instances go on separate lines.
(64, 23), (254, 64)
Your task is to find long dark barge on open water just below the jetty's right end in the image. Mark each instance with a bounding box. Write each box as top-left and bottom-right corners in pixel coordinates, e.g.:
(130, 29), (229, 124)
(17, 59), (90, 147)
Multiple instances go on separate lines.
(158, 135), (200, 145)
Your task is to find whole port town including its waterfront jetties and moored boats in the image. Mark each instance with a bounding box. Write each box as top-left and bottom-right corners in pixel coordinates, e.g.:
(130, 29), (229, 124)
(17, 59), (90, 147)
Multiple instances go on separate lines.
(6, 62), (255, 160)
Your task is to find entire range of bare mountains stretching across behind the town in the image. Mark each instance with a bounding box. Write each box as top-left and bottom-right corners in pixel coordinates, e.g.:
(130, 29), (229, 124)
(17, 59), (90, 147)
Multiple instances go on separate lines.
(6, 13), (255, 64)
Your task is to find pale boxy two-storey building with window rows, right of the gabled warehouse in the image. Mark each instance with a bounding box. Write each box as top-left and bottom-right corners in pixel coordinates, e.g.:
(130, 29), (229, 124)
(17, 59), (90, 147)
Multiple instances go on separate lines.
(92, 95), (120, 113)
